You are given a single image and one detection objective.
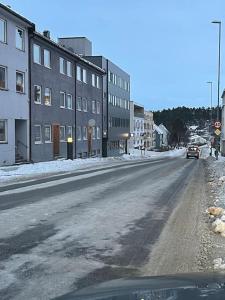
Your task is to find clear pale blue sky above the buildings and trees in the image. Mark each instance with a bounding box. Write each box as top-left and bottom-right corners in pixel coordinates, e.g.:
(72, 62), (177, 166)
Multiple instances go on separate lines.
(2, 0), (225, 110)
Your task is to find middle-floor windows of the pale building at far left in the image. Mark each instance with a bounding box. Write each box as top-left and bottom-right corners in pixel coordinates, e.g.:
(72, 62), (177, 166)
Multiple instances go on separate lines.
(0, 66), (25, 93)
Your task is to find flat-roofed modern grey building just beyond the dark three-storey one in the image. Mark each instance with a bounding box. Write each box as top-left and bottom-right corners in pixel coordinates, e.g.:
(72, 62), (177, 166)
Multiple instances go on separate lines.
(59, 37), (130, 157)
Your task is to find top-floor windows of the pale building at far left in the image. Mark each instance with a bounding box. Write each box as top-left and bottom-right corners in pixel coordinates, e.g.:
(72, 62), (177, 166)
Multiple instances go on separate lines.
(0, 18), (25, 51)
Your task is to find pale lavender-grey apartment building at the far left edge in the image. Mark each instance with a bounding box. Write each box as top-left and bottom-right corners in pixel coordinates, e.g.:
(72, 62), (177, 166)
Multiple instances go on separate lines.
(0, 4), (34, 165)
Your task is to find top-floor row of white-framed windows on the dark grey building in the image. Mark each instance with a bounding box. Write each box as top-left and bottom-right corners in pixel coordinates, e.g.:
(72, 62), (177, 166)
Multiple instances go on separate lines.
(33, 44), (100, 89)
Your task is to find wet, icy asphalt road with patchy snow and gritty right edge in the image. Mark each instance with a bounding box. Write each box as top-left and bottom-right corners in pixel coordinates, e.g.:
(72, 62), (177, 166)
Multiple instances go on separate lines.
(0, 157), (207, 299)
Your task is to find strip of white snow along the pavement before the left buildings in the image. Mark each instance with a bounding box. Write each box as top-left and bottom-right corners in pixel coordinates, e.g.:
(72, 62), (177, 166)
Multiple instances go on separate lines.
(0, 148), (185, 184)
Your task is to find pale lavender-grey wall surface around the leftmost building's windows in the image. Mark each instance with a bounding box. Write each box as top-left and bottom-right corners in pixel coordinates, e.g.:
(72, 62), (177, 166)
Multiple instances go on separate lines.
(0, 8), (29, 165)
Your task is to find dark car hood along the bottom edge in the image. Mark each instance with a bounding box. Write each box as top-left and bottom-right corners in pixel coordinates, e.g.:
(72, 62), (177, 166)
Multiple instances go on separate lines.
(55, 273), (225, 300)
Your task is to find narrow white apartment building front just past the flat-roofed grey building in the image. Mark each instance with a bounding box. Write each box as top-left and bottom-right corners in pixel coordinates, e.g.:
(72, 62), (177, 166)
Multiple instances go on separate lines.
(130, 101), (145, 148)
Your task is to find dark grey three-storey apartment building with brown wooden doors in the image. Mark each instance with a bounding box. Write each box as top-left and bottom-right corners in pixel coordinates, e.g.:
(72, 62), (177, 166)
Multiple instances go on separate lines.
(30, 31), (104, 162)
